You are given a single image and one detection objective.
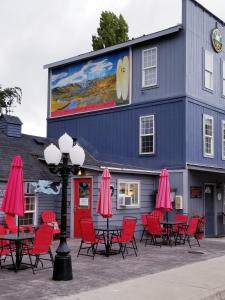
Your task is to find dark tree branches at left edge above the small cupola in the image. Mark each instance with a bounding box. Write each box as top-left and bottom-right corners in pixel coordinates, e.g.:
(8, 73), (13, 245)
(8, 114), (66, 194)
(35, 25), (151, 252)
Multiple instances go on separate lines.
(0, 86), (22, 115)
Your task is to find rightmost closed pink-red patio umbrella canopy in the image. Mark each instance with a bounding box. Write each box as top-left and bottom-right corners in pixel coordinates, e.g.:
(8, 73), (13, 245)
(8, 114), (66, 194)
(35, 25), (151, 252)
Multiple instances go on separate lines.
(156, 169), (173, 212)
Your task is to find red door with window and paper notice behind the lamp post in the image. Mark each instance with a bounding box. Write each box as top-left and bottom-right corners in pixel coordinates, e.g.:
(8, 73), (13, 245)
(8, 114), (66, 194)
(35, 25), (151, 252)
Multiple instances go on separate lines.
(74, 178), (92, 238)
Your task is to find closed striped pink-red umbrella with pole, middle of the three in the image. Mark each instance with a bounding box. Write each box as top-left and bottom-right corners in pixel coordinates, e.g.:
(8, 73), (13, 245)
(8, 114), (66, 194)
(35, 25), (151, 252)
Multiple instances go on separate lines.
(96, 168), (112, 255)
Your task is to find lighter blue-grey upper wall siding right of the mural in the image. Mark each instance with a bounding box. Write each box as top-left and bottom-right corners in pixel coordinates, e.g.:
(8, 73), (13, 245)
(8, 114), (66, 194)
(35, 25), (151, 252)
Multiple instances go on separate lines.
(132, 31), (185, 103)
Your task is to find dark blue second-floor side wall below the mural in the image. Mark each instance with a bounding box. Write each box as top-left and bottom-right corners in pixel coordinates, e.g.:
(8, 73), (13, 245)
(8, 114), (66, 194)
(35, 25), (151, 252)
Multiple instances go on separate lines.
(48, 98), (185, 169)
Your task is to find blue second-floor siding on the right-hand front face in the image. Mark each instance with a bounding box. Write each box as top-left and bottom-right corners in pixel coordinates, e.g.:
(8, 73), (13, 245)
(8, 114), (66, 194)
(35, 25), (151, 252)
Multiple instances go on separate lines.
(186, 98), (225, 168)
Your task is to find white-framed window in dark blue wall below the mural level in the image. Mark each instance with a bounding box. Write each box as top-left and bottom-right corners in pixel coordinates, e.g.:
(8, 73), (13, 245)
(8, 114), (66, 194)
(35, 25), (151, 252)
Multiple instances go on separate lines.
(139, 115), (155, 154)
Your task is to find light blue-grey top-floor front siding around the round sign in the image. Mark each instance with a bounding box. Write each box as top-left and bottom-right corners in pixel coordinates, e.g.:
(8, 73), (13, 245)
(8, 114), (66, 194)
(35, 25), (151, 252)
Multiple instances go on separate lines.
(183, 0), (225, 109)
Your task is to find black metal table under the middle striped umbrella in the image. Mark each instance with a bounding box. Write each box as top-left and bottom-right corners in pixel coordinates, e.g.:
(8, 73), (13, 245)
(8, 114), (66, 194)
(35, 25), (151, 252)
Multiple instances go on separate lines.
(95, 225), (121, 257)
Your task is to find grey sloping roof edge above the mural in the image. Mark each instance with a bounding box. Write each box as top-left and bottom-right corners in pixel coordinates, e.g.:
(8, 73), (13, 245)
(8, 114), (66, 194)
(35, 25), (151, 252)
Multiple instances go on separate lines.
(44, 24), (183, 69)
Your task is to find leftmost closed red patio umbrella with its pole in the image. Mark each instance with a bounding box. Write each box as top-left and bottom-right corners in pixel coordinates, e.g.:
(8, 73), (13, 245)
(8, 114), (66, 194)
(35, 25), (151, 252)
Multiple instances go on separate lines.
(1, 155), (24, 234)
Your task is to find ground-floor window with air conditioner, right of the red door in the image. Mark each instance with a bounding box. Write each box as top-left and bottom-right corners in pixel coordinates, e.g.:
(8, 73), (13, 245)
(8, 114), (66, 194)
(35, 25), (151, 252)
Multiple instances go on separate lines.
(117, 179), (140, 208)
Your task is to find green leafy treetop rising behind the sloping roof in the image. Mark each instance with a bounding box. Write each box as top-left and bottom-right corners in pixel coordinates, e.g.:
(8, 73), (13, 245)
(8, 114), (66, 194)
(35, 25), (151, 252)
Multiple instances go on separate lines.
(92, 11), (129, 51)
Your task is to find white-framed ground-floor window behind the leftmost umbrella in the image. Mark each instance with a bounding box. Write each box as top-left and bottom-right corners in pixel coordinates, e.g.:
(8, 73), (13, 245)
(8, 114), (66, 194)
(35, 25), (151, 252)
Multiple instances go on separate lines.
(19, 182), (37, 226)
